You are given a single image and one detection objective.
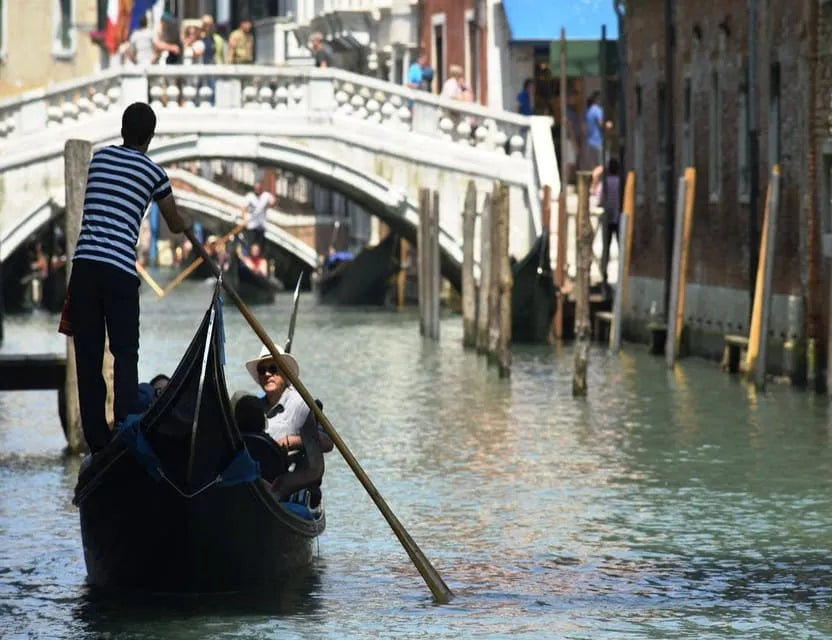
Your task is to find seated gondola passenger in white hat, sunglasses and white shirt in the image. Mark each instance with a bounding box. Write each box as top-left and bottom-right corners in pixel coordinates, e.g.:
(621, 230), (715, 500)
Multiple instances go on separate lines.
(235, 347), (333, 506)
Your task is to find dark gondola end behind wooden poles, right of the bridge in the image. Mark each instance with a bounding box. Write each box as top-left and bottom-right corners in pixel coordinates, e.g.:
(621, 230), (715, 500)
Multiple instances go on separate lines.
(511, 227), (556, 343)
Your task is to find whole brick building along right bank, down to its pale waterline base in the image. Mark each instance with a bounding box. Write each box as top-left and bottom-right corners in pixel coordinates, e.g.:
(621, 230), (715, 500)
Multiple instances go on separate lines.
(624, 0), (832, 379)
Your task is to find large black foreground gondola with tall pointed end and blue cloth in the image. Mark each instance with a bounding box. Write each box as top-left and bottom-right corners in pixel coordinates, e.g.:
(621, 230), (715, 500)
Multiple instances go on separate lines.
(74, 292), (325, 593)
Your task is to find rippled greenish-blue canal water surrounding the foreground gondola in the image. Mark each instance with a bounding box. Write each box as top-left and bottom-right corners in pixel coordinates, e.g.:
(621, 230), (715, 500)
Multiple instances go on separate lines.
(0, 282), (832, 639)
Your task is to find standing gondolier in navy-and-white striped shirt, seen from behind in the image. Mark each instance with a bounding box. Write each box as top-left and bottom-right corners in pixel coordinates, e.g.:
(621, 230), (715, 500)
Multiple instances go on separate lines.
(69, 102), (191, 453)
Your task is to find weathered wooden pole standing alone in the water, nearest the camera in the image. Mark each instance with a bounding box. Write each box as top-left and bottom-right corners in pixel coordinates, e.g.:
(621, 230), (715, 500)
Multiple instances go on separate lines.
(572, 171), (595, 396)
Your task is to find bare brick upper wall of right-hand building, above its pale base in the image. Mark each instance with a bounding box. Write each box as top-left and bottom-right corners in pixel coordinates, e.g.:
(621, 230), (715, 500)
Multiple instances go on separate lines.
(626, 0), (808, 295)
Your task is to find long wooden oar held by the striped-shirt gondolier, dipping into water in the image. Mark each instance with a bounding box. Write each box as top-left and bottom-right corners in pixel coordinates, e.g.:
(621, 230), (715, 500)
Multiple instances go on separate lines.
(185, 229), (453, 604)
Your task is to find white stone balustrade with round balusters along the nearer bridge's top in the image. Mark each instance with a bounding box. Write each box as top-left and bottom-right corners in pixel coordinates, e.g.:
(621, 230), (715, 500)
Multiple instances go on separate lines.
(0, 65), (532, 157)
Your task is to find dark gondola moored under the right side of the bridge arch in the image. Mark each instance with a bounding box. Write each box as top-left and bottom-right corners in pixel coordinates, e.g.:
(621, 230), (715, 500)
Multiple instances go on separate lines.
(317, 233), (398, 306)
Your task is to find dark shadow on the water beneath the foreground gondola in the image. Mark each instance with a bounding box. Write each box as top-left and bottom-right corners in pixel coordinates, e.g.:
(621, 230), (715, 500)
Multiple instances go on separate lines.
(73, 560), (321, 638)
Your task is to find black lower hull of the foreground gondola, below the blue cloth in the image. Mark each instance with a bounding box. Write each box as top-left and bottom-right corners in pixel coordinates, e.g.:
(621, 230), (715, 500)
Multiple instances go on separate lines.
(79, 445), (325, 593)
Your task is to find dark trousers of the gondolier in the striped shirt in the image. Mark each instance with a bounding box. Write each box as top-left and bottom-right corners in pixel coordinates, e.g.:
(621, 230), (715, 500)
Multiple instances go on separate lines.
(69, 260), (139, 453)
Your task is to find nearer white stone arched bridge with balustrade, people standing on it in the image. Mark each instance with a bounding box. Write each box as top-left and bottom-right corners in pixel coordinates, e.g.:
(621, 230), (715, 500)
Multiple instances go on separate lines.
(0, 65), (560, 279)
